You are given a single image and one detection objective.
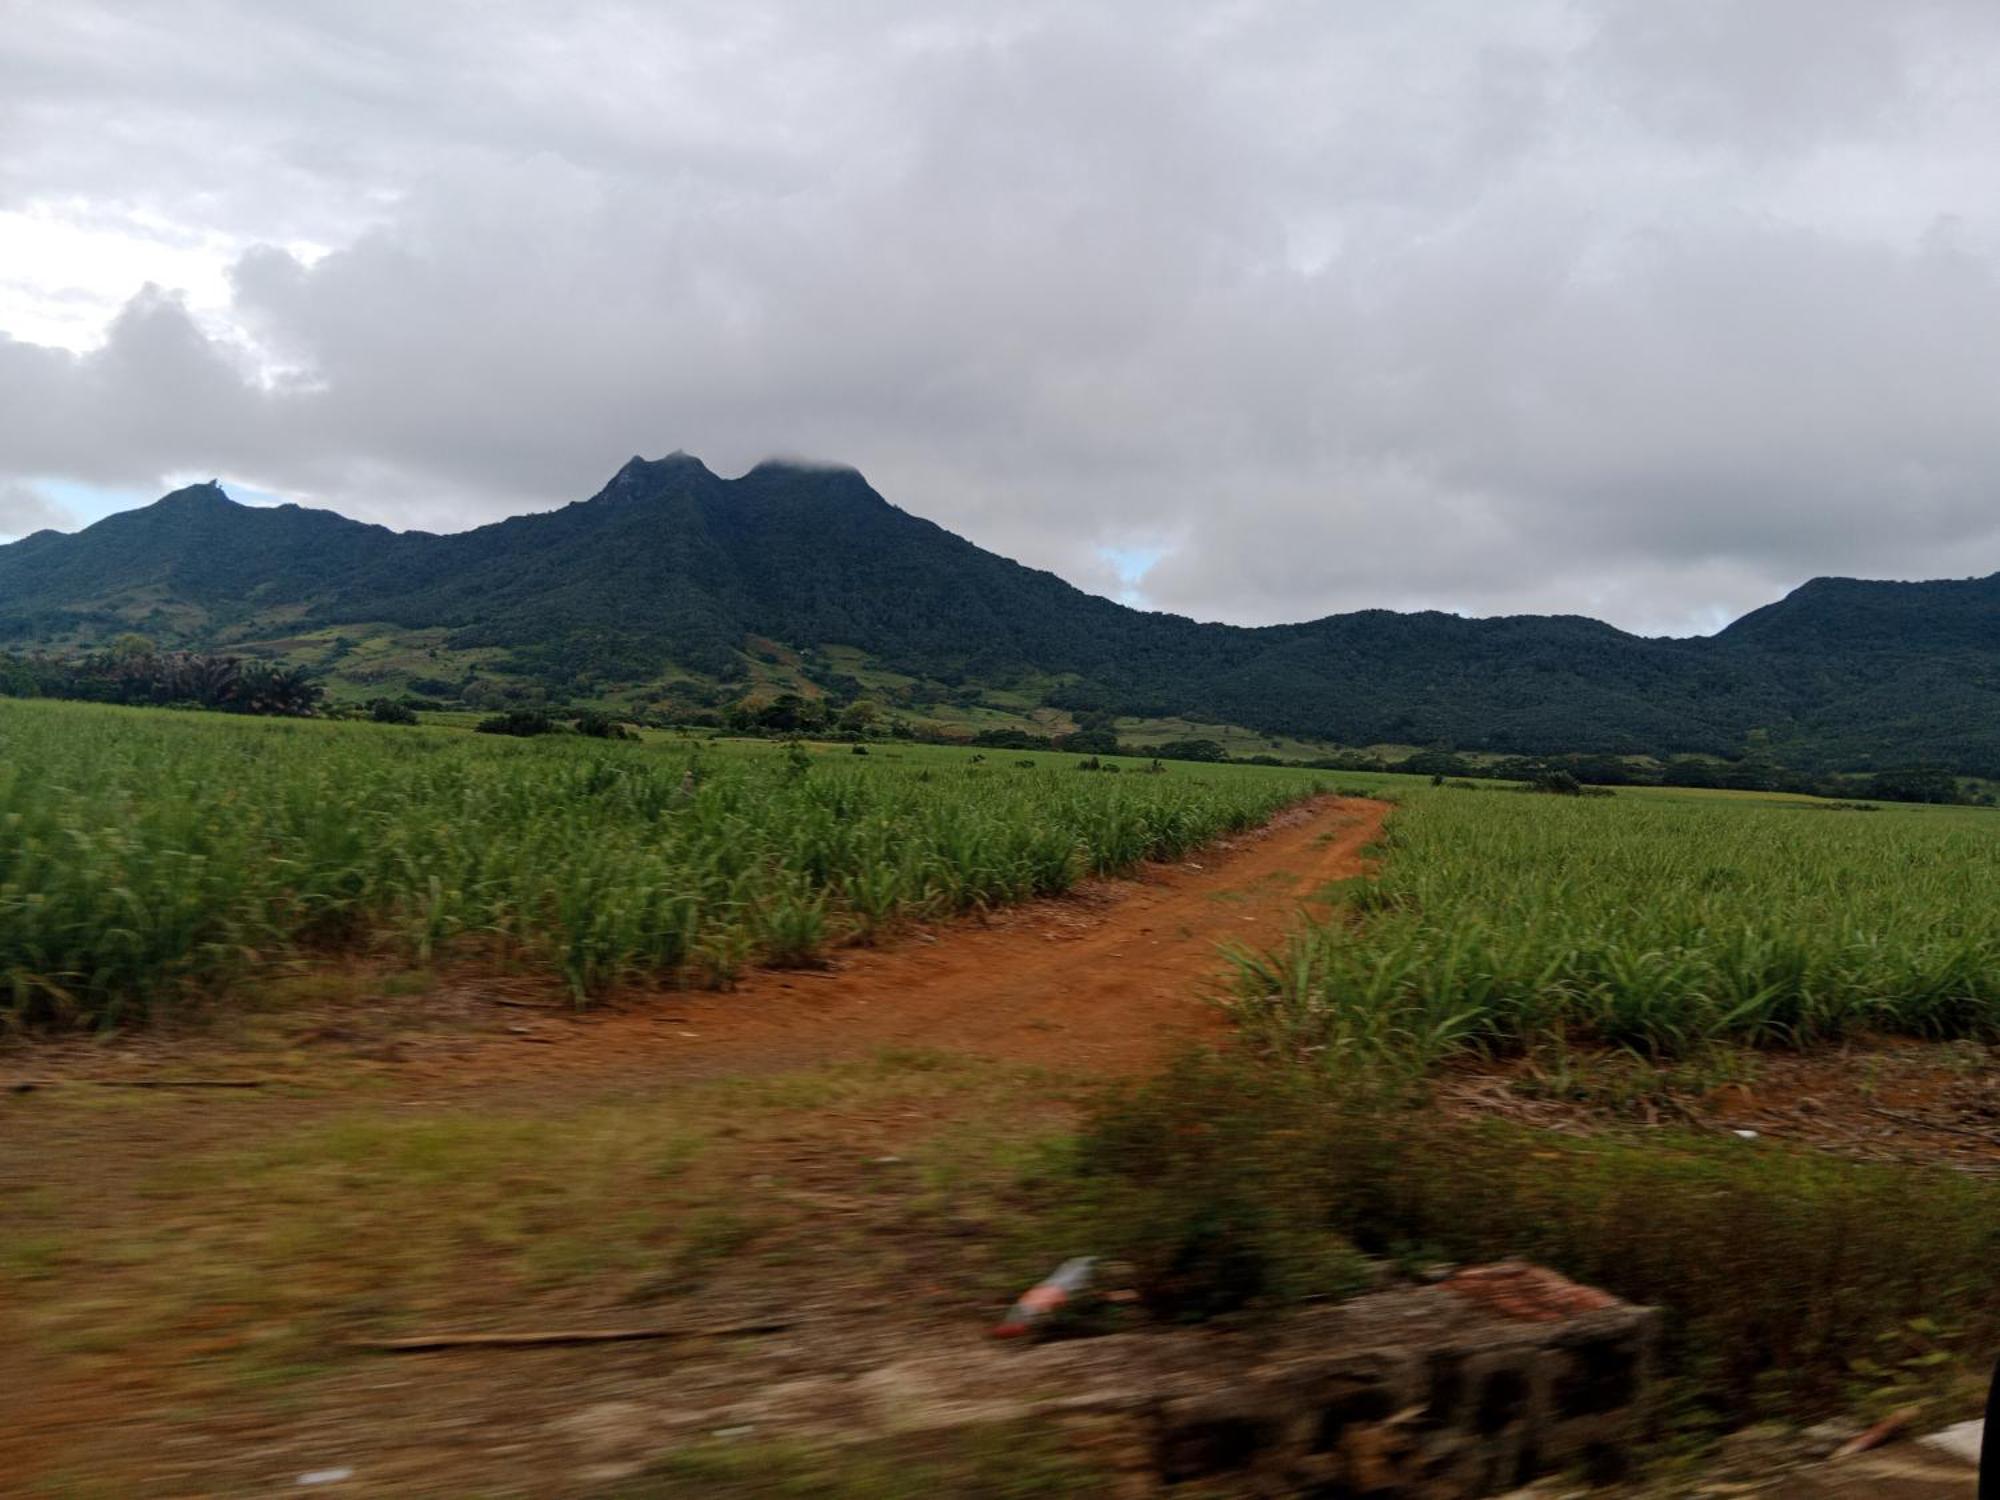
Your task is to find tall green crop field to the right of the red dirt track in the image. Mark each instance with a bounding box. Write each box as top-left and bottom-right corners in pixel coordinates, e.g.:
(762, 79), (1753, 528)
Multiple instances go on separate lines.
(1240, 788), (2000, 1060)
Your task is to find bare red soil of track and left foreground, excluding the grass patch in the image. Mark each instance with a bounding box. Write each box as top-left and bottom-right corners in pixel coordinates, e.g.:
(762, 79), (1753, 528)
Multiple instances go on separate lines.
(0, 798), (1386, 1494)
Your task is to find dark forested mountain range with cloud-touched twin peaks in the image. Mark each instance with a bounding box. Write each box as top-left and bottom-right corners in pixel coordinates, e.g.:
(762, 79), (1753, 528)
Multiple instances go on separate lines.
(0, 454), (2000, 776)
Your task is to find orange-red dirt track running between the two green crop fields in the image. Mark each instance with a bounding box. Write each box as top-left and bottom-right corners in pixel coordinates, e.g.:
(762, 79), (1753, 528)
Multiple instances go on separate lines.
(410, 798), (1388, 1084)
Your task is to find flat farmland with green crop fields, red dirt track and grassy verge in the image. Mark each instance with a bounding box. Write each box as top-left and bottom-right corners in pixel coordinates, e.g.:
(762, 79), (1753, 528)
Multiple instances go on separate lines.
(0, 702), (2000, 1494)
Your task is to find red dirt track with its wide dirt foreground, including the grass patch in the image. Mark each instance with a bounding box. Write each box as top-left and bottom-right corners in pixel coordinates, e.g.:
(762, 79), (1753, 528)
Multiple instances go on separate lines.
(0, 798), (1386, 1496)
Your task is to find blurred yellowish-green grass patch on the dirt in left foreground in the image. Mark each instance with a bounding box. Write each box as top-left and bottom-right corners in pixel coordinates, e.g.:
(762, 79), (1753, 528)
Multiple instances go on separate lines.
(0, 1048), (1074, 1416)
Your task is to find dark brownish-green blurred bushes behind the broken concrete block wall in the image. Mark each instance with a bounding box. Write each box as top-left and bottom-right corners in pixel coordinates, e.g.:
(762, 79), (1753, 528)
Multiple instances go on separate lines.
(1068, 1056), (2000, 1424)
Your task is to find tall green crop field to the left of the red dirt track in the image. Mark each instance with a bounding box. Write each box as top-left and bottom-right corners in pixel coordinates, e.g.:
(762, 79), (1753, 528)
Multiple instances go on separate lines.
(0, 700), (1312, 1024)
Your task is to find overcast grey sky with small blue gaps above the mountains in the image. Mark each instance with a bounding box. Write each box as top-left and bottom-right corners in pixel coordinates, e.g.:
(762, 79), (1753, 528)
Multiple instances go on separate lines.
(0, 0), (2000, 634)
